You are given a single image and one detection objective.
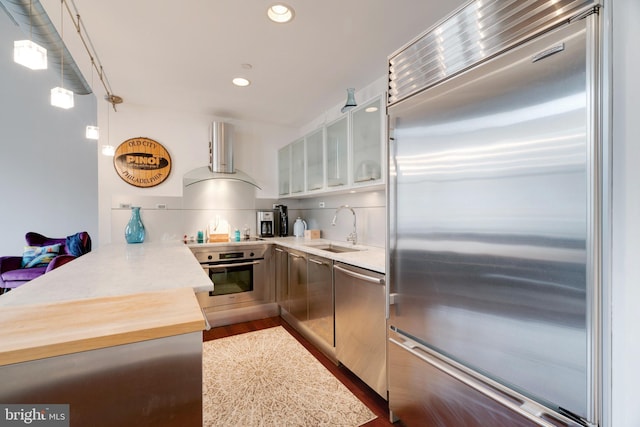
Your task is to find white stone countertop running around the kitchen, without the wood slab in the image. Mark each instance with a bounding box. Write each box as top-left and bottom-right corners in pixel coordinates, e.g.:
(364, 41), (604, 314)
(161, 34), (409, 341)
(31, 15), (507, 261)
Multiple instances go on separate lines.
(0, 237), (385, 307)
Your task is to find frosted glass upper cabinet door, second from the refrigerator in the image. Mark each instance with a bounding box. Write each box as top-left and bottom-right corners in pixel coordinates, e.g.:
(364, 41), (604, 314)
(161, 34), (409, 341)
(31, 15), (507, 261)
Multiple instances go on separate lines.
(326, 115), (349, 188)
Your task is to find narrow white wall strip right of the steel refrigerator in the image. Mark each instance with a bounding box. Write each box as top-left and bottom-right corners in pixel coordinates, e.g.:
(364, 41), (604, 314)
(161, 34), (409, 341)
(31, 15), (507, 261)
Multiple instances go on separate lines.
(607, 0), (640, 427)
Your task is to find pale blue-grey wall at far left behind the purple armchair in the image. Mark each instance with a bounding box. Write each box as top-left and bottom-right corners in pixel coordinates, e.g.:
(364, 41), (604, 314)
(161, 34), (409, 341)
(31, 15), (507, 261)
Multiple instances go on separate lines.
(0, 12), (99, 256)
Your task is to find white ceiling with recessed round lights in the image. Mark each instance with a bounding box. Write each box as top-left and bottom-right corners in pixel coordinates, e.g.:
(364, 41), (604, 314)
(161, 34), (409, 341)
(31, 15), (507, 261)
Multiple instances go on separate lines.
(41, 0), (465, 127)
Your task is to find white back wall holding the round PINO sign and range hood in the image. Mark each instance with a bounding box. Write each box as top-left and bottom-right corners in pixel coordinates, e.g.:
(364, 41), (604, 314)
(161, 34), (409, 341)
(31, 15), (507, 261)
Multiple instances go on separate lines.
(98, 99), (298, 243)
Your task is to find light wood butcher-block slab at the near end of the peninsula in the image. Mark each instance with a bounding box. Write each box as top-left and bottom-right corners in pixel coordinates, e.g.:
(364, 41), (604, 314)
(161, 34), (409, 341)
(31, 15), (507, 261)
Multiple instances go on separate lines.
(0, 288), (205, 366)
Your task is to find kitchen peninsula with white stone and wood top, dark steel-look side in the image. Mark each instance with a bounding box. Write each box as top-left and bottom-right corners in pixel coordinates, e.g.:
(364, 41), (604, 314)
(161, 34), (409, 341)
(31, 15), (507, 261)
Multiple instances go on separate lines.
(0, 242), (210, 426)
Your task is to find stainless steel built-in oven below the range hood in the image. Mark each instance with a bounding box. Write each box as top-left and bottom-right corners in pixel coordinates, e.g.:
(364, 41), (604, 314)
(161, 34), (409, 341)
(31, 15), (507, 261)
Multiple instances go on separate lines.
(191, 245), (273, 308)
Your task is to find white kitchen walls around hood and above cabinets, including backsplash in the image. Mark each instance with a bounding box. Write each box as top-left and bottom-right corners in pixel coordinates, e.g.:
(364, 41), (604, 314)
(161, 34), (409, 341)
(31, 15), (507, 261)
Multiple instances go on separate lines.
(98, 82), (386, 247)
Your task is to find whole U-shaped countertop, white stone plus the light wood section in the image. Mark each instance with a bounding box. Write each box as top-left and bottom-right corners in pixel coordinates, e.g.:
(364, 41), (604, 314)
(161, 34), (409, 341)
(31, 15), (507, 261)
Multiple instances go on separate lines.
(0, 237), (385, 366)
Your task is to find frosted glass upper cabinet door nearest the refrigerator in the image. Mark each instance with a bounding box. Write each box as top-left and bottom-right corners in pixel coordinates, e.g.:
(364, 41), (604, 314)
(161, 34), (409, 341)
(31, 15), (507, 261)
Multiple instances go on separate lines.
(351, 97), (383, 184)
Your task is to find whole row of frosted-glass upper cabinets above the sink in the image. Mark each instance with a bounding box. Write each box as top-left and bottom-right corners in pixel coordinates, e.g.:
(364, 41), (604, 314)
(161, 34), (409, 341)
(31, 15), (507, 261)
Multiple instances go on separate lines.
(278, 96), (387, 197)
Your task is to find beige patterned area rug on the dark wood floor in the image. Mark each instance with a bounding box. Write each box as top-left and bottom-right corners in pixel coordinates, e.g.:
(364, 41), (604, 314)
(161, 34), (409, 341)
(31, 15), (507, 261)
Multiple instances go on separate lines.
(202, 326), (376, 427)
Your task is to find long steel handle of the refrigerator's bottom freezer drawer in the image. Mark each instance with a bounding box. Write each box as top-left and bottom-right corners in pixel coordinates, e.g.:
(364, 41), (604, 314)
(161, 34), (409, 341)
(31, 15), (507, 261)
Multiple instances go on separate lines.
(389, 336), (587, 427)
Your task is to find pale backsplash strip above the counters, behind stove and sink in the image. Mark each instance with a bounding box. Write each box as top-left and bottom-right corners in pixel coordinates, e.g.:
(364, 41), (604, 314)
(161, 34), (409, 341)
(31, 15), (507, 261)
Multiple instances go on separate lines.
(111, 191), (386, 248)
